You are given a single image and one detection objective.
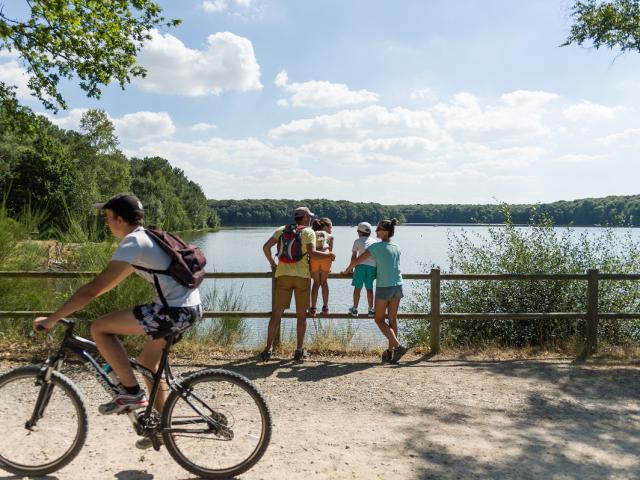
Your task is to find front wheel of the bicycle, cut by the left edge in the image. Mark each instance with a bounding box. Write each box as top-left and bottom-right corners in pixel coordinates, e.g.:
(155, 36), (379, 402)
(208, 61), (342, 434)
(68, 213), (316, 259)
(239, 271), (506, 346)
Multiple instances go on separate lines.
(0, 365), (88, 477)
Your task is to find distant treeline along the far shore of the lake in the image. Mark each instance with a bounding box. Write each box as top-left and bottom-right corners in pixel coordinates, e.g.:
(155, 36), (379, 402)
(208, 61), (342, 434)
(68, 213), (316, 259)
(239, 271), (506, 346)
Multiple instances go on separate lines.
(209, 195), (640, 226)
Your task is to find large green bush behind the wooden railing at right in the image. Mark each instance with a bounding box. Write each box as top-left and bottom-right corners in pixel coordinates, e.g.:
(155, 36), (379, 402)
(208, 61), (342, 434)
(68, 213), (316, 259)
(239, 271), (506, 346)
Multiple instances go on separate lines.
(403, 210), (640, 348)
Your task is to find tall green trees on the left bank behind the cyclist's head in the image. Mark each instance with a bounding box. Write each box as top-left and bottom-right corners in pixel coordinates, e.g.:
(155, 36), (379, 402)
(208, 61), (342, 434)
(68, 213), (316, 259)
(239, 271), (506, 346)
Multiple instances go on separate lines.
(0, 105), (218, 237)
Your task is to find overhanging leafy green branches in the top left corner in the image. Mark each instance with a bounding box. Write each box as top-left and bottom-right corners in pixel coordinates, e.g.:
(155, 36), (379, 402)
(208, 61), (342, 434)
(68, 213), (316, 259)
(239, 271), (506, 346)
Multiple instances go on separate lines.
(0, 0), (180, 111)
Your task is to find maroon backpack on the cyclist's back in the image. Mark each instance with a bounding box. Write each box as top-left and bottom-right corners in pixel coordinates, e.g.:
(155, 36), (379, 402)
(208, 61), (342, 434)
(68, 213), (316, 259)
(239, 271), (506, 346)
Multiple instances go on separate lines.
(132, 226), (207, 305)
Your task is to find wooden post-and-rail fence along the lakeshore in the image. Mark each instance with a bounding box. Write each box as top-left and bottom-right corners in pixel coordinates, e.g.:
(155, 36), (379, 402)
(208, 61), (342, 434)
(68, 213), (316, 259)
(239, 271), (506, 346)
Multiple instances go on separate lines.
(0, 269), (640, 358)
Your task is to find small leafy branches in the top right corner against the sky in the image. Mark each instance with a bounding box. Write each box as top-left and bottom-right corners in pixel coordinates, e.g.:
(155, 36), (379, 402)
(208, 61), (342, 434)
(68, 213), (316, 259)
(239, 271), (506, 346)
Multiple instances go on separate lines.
(562, 0), (640, 52)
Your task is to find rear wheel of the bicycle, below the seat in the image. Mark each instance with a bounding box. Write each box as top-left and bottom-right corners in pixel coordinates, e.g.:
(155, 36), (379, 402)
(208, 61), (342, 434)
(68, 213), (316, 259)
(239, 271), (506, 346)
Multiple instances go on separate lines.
(162, 370), (271, 478)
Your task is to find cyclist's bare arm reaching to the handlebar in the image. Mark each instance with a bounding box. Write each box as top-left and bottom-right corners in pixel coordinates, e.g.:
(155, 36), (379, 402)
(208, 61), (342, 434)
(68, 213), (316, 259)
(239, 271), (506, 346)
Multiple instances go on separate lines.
(34, 260), (134, 330)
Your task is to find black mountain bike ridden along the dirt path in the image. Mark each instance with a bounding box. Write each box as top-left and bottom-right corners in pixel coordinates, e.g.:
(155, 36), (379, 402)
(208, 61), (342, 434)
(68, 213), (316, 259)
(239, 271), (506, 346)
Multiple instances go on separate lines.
(0, 319), (272, 478)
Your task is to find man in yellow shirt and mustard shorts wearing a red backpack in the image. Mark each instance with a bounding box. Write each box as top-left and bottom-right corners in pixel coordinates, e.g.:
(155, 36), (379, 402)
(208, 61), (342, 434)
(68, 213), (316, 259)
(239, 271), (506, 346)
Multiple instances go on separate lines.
(260, 207), (336, 361)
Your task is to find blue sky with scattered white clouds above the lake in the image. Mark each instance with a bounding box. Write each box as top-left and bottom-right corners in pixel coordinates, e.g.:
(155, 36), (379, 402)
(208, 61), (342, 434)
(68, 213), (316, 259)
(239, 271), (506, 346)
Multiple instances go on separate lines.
(0, 0), (640, 204)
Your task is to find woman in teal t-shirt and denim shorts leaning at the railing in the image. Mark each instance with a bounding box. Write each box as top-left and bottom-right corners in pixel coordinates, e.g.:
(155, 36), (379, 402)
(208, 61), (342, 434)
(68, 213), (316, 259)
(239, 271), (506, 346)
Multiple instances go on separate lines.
(343, 218), (407, 363)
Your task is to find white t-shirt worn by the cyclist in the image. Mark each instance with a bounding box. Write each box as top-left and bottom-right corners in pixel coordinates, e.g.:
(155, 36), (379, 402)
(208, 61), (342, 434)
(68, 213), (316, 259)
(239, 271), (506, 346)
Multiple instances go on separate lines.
(111, 227), (200, 307)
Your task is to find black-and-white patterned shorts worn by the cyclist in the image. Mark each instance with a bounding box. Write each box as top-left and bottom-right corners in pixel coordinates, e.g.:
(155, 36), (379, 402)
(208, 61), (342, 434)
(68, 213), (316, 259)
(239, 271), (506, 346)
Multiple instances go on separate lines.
(133, 303), (202, 342)
